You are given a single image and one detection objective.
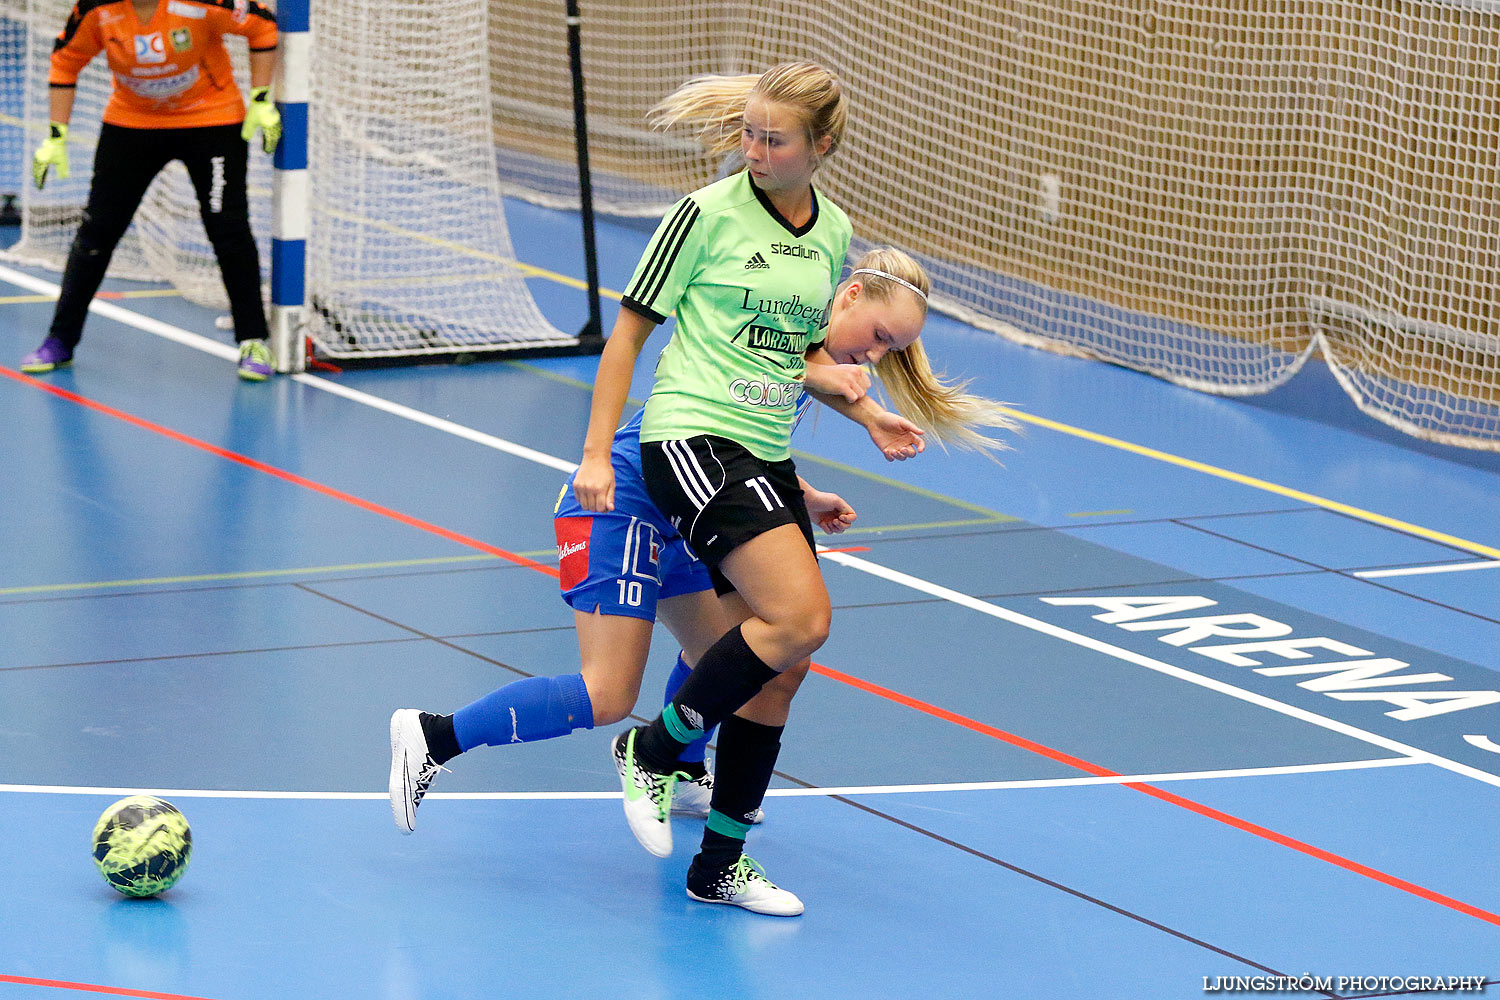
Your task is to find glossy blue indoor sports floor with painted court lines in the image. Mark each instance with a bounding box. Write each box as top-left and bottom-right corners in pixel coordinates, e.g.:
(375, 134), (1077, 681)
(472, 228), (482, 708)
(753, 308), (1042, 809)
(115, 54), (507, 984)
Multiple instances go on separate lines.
(0, 194), (1500, 1000)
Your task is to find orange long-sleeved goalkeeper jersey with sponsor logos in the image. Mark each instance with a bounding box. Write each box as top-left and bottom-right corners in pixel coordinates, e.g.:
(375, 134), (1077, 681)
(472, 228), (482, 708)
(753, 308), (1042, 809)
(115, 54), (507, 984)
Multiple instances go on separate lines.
(48, 0), (276, 129)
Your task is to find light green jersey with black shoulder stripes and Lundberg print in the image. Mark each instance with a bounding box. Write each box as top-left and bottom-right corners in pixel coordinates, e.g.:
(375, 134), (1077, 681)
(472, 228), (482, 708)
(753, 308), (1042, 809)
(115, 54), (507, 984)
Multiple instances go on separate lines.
(624, 171), (852, 462)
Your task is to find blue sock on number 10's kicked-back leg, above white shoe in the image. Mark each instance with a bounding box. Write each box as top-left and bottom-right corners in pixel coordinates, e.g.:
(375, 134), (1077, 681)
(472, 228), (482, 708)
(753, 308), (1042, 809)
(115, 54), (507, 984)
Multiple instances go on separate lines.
(453, 673), (594, 751)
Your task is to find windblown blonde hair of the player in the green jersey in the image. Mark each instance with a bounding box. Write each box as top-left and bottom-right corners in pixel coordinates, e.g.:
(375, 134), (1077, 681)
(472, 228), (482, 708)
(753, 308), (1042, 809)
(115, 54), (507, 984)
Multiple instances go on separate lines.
(647, 63), (849, 156)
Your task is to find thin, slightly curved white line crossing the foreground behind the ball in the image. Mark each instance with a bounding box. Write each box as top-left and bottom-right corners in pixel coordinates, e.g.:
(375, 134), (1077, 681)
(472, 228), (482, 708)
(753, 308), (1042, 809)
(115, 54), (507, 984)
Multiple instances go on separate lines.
(0, 757), (1424, 802)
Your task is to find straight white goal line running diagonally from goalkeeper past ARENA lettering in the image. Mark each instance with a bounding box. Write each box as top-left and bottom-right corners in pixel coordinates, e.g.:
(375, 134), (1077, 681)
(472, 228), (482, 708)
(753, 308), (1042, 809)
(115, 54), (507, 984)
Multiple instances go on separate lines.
(0, 265), (1500, 787)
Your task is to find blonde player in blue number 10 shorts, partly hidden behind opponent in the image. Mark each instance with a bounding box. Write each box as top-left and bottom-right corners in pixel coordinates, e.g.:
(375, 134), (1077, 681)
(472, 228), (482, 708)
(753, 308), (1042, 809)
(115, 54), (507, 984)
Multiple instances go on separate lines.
(390, 247), (1013, 899)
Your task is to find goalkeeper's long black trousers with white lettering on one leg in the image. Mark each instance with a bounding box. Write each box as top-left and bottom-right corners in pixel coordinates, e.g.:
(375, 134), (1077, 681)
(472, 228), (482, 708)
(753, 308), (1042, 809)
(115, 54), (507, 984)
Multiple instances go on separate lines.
(51, 123), (266, 348)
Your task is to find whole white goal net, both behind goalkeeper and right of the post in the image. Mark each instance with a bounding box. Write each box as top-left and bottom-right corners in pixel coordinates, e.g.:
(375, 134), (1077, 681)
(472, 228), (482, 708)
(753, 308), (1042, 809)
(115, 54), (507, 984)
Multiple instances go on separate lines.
(0, 0), (578, 360)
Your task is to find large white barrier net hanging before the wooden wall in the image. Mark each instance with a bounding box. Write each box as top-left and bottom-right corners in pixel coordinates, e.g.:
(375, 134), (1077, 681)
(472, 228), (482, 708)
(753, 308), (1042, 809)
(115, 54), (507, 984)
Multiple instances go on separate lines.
(491, 0), (1500, 448)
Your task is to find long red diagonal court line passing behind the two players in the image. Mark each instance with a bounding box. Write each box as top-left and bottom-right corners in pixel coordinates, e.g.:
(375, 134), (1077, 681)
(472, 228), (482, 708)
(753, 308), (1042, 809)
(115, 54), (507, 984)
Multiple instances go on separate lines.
(14, 366), (1500, 929)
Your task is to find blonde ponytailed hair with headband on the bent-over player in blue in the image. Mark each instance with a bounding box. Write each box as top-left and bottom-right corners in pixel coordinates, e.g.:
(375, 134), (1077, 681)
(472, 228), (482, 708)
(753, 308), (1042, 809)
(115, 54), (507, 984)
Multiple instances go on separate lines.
(845, 246), (1020, 457)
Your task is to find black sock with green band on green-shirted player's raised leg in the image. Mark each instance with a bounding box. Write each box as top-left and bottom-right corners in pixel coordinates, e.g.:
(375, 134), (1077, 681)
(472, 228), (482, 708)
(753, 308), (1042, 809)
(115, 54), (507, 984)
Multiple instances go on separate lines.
(636, 625), (777, 774)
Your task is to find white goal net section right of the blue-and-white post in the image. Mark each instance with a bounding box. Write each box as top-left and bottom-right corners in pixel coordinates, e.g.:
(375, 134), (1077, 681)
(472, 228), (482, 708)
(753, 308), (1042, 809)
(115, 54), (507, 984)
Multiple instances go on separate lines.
(308, 0), (576, 357)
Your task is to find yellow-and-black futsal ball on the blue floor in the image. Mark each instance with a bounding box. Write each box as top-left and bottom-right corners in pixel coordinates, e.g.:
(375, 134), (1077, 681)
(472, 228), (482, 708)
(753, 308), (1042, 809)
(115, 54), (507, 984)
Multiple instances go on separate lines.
(93, 795), (192, 897)
